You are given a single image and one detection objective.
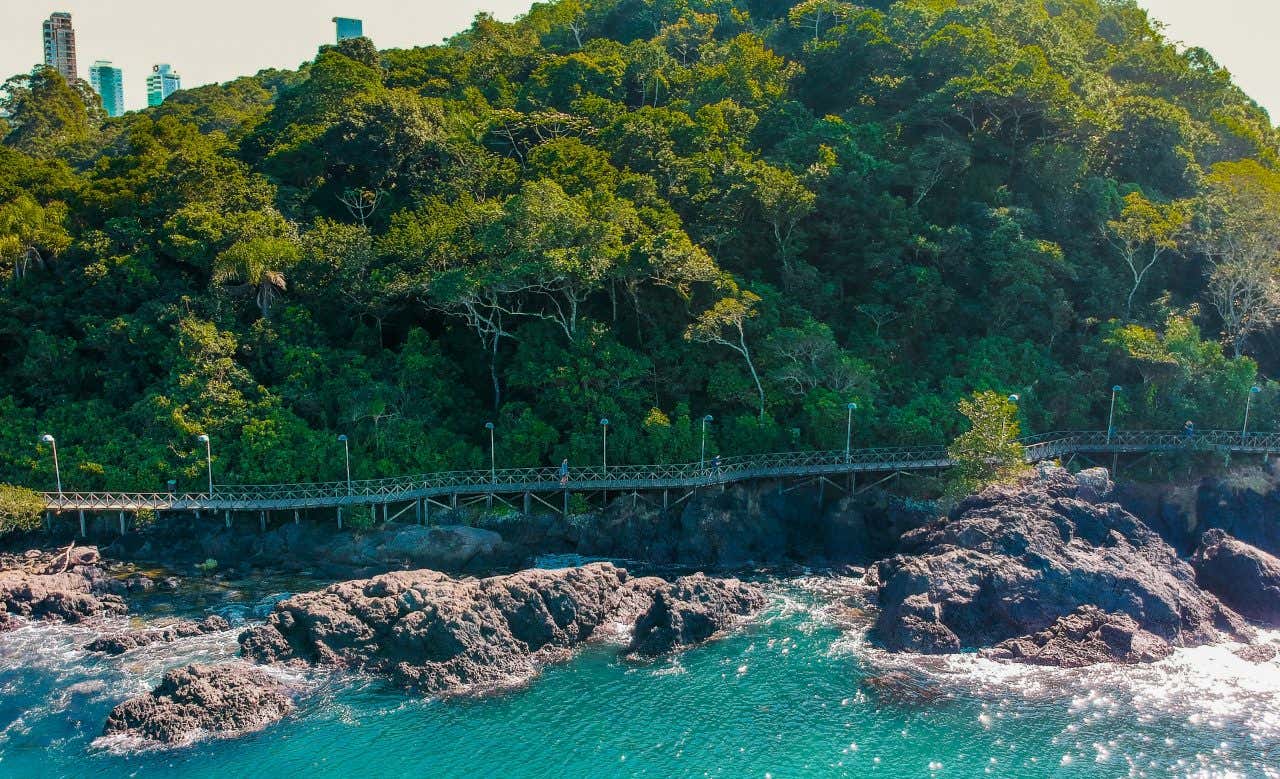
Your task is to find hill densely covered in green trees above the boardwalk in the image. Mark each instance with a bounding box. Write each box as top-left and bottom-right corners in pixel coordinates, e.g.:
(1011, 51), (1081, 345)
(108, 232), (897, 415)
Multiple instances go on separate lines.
(0, 0), (1280, 489)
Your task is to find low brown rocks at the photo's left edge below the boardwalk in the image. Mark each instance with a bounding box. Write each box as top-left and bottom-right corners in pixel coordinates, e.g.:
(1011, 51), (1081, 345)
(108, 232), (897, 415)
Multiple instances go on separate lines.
(0, 546), (127, 629)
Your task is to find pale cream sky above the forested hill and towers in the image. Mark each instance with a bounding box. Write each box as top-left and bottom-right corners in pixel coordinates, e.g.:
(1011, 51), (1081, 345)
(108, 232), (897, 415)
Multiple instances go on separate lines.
(0, 0), (1280, 116)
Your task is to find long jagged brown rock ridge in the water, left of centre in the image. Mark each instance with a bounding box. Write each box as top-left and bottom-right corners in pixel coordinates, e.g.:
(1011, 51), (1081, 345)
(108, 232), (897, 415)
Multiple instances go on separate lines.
(241, 563), (757, 695)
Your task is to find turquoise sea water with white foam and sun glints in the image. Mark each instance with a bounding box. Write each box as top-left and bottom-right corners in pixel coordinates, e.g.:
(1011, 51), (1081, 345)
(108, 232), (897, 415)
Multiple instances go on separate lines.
(0, 577), (1280, 779)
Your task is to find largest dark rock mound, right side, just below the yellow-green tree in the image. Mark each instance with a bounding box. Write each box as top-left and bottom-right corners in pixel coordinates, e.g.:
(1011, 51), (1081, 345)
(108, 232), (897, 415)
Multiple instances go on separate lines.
(867, 468), (1249, 654)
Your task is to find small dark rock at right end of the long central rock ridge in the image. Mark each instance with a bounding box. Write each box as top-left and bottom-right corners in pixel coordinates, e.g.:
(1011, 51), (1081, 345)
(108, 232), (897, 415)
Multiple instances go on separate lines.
(627, 573), (764, 656)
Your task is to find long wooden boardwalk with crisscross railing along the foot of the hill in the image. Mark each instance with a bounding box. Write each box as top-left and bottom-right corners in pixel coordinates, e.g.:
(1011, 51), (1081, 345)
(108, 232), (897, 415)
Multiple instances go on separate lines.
(44, 430), (1280, 512)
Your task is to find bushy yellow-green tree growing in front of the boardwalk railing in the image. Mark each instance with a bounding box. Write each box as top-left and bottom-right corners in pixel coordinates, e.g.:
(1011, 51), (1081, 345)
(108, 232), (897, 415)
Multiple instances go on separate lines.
(946, 390), (1027, 498)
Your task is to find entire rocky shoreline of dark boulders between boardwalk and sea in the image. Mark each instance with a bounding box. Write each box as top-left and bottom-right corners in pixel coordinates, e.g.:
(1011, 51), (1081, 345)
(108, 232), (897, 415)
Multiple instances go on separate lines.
(0, 467), (1280, 746)
